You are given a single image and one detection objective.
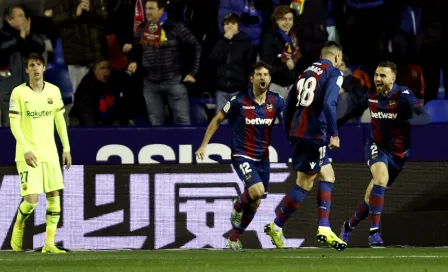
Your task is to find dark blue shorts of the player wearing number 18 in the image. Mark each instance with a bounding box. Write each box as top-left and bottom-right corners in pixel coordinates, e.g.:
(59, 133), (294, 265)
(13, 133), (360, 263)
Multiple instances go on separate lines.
(291, 137), (330, 174)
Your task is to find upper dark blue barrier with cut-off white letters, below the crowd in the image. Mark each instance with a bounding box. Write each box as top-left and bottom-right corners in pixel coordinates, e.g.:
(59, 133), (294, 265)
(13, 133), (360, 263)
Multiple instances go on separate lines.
(0, 124), (448, 165)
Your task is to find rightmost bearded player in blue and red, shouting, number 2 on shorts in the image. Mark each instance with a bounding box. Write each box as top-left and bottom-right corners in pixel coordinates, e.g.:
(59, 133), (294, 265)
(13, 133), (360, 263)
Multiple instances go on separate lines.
(338, 61), (430, 247)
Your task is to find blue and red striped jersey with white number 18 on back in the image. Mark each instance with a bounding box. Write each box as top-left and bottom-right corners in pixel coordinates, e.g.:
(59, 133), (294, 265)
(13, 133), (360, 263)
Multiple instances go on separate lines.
(284, 59), (344, 140)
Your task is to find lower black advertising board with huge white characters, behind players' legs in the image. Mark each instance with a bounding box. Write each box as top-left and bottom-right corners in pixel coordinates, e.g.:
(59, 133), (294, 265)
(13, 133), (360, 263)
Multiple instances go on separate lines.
(0, 162), (448, 249)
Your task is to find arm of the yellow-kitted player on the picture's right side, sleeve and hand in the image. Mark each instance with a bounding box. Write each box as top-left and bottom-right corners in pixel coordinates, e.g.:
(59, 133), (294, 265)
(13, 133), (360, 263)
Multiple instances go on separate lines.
(54, 90), (72, 169)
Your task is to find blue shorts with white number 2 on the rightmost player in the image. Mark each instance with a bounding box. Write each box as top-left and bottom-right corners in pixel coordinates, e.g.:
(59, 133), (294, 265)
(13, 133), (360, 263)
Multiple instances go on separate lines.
(364, 142), (407, 187)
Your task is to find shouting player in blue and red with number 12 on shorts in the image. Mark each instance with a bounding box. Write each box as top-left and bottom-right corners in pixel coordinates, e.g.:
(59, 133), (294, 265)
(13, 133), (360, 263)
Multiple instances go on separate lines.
(196, 62), (284, 250)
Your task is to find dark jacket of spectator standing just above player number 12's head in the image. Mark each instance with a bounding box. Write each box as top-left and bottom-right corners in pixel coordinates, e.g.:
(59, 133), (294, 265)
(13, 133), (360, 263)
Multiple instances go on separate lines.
(210, 32), (255, 92)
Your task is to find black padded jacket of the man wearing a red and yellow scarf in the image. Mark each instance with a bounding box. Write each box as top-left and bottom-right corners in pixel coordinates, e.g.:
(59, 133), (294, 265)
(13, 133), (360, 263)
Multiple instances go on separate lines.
(130, 19), (202, 82)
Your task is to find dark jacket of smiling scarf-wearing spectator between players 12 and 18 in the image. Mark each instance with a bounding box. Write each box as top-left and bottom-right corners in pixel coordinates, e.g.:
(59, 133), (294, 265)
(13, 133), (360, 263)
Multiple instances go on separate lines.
(260, 28), (297, 87)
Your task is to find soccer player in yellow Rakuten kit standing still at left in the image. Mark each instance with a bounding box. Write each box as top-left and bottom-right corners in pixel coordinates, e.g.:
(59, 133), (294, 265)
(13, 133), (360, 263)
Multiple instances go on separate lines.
(9, 54), (72, 253)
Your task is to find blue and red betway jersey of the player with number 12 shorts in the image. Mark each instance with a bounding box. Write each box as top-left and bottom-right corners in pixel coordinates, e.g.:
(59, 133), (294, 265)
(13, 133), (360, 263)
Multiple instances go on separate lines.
(221, 89), (284, 160)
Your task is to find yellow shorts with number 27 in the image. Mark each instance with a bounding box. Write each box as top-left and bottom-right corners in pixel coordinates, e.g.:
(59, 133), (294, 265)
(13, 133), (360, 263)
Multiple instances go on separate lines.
(16, 161), (64, 196)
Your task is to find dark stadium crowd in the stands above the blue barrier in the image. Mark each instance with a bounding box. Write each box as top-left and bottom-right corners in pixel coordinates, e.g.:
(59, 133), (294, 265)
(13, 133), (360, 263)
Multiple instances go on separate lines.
(0, 0), (448, 126)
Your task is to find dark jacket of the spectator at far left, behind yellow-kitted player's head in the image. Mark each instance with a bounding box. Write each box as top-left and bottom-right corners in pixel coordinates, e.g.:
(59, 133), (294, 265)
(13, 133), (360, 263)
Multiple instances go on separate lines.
(0, 21), (45, 100)
